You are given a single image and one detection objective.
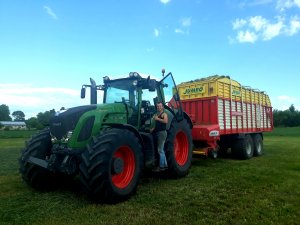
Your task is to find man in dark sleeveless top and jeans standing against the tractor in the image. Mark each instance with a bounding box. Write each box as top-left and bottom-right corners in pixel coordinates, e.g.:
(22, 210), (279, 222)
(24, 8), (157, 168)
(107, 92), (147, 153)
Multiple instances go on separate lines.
(151, 102), (168, 172)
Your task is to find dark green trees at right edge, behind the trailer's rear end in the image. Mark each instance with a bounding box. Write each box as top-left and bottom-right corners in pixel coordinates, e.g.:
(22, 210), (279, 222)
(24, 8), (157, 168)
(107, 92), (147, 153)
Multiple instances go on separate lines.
(273, 105), (300, 127)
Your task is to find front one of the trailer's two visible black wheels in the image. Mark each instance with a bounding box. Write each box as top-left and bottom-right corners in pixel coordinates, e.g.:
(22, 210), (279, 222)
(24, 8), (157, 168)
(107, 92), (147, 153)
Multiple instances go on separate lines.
(232, 134), (254, 159)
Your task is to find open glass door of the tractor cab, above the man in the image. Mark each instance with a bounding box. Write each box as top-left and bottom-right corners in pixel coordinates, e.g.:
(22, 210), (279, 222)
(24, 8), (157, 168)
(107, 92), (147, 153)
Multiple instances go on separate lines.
(160, 73), (183, 121)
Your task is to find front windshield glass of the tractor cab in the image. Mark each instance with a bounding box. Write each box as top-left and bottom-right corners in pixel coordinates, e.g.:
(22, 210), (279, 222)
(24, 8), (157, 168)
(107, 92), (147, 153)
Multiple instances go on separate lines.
(103, 79), (137, 107)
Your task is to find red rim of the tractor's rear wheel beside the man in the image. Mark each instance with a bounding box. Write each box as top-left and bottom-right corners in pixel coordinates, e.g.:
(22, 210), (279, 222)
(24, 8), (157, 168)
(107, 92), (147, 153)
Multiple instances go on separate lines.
(174, 131), (189, 166)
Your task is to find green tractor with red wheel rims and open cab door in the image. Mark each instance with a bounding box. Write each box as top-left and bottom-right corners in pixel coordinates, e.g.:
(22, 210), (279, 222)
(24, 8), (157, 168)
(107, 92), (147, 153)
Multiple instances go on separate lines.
(19, 71), (192, 203)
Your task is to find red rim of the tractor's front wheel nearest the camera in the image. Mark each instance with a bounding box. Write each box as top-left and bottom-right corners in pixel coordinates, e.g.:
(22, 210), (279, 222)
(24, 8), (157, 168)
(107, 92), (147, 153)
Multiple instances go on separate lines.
(112, 146), (135, 189)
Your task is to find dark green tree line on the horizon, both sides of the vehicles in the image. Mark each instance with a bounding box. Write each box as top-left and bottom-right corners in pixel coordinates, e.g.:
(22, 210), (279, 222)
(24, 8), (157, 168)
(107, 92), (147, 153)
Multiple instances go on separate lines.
(0, 104), (300, 129)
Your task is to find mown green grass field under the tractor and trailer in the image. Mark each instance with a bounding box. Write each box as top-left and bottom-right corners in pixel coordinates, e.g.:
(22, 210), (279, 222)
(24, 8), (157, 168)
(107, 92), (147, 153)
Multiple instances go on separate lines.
(0, 127), (300, 225)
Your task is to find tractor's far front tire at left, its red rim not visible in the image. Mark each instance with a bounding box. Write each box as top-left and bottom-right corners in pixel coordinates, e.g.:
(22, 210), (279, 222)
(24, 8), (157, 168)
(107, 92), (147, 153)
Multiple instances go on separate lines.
(19, 129), (57, 191)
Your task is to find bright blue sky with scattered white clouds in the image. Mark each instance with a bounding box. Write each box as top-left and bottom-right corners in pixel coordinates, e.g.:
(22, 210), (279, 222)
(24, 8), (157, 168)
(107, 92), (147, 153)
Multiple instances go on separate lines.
(0, 0), (300, 119)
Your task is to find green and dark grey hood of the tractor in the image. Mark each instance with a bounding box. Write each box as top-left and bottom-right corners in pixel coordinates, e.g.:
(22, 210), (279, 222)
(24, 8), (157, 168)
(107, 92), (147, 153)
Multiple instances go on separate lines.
(50, 103), (132, 147)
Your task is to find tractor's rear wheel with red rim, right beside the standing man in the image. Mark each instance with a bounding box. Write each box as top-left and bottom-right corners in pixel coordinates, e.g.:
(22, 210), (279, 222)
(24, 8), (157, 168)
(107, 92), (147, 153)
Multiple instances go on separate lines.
(165, 119), (193, 177)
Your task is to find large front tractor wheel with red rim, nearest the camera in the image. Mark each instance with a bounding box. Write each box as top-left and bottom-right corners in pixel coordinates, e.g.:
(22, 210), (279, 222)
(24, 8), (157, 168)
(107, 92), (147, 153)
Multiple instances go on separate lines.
(79, 129), (143, 203)
